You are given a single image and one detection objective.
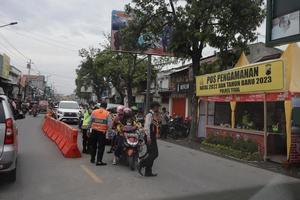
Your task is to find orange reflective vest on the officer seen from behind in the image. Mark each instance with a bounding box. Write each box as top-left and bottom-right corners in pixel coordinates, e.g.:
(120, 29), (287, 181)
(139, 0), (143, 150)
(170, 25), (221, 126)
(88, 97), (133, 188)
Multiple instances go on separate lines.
(91, 108), (109, 133)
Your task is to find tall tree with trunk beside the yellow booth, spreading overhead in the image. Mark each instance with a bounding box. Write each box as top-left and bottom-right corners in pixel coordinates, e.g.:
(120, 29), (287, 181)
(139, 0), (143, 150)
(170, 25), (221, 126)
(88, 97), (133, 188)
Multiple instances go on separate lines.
(126, 0), (265, 136)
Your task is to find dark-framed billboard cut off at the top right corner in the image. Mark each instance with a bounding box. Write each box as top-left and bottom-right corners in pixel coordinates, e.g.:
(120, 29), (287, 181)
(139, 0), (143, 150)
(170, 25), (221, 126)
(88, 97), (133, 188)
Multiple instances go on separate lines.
(266, 0), (300, 46)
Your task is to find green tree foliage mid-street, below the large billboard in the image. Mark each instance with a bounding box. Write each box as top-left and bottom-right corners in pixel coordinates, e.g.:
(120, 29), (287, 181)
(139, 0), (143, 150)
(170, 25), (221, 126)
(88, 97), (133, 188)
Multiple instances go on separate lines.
(76, 48), (157, 105)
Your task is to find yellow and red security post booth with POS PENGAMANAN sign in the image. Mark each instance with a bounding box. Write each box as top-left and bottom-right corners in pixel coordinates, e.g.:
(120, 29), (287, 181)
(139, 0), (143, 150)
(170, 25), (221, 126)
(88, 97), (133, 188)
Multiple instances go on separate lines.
(196, 44), (300, 163)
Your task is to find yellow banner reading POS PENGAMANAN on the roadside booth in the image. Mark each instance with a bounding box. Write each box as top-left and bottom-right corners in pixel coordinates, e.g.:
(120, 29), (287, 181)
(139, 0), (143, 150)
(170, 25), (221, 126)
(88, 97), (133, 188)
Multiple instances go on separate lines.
(196, 60), (284, 96)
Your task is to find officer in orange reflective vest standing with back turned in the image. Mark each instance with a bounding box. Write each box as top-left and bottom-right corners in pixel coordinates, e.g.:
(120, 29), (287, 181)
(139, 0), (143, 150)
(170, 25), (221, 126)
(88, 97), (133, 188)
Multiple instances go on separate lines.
(89, 102), (111, 166)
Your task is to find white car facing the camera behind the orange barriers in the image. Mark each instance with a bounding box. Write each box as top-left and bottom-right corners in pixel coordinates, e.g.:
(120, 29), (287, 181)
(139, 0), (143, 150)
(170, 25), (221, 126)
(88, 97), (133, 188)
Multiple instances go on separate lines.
(56, 101), (79, 123)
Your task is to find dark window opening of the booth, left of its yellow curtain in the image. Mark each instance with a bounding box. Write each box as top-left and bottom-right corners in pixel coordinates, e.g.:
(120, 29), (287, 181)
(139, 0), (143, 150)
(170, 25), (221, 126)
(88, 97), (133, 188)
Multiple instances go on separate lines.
(214, 102), (231, 127)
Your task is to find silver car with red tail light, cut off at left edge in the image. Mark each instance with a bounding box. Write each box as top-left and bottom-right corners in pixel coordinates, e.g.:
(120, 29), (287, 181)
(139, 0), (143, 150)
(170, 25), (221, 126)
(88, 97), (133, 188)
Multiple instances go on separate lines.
(0, 93), (18, 182)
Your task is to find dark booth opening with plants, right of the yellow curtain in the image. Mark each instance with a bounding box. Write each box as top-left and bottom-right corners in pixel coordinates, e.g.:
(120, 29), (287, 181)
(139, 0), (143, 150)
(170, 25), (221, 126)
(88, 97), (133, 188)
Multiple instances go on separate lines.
(235, 102), (264, 131)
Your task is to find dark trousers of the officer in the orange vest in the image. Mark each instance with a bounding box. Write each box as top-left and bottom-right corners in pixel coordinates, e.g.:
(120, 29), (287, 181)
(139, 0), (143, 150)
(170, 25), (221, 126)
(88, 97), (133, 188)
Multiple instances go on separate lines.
(90, 130), (106, 162)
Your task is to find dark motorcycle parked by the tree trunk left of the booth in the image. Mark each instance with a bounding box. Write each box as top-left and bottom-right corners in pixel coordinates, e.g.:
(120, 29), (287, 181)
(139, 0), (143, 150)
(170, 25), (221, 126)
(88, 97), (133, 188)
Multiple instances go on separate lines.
(168, 116), (191, 140)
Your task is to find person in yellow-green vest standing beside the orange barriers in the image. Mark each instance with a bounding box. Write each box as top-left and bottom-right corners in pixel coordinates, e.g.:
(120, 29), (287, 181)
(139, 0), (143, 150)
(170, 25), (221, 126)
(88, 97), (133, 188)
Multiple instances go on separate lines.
(81, 106), (91, 153)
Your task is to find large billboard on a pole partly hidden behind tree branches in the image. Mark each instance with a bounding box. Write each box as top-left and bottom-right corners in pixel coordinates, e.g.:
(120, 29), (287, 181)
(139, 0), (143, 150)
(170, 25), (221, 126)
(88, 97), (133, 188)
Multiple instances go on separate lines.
(111, 10), (173, 56)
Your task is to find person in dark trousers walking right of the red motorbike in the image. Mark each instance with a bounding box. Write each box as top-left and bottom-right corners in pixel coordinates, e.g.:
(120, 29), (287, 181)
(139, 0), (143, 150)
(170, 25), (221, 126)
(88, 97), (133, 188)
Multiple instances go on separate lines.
(138, 102), (160, 177)
